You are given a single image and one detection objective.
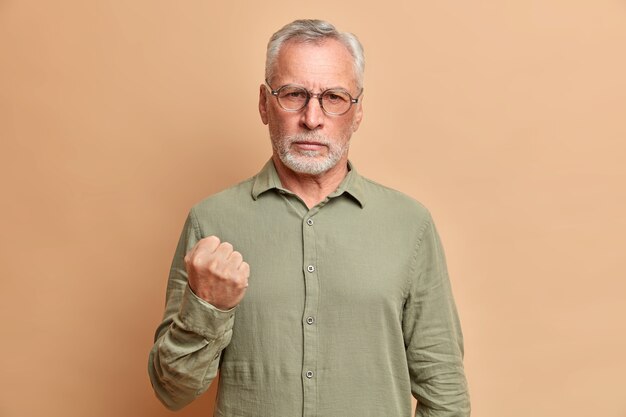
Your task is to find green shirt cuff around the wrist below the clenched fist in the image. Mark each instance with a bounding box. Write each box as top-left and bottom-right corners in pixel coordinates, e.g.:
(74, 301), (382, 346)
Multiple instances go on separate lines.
(179, 284), (237, 340)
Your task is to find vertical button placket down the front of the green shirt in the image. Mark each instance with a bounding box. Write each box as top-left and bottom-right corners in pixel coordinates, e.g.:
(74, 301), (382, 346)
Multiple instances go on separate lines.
(302, 213), (319, 416)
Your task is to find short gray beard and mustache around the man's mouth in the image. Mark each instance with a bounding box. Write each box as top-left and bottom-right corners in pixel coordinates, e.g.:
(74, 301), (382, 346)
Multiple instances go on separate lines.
(271, 132), (350, 175)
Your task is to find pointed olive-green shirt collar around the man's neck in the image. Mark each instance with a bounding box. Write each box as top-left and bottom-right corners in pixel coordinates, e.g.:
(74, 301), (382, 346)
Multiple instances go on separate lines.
(252, 159), (366, 208)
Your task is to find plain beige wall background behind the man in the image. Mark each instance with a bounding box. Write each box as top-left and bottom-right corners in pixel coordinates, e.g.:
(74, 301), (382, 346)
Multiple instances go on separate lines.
(0, 0), (626, 417)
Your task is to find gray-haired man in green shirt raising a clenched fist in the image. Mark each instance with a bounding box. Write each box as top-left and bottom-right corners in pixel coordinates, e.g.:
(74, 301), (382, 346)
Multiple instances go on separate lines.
(149, 20), (469, 417)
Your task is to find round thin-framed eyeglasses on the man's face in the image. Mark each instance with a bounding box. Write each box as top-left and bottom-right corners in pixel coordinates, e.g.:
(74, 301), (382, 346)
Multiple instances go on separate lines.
(265, 80), (363, 116)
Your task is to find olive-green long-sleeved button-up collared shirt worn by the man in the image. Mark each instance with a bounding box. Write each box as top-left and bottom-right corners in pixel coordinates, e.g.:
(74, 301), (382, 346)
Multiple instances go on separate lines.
(149, 161), (469, 417)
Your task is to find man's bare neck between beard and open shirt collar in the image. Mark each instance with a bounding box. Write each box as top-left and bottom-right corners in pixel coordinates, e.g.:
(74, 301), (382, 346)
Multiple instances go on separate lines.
(272, 155), (348, 208)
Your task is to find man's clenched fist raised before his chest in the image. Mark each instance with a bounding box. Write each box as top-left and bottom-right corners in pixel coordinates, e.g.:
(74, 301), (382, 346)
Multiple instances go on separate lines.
(185, 236), (250, 310)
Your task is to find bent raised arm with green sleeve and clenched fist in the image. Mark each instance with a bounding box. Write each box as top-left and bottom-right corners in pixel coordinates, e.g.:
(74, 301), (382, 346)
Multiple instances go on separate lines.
(148, 210), (249, 410)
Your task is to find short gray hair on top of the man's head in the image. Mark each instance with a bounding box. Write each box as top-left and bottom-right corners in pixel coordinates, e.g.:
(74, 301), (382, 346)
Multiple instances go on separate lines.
(265, 19), (365, 89)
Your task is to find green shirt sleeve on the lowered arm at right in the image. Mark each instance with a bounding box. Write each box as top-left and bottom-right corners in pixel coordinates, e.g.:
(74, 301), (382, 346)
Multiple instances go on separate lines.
(402, 216), (470, 417)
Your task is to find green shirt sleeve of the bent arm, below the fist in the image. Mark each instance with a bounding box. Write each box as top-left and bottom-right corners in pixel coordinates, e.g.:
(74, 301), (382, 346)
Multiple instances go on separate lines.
(148, 211), (234, 410)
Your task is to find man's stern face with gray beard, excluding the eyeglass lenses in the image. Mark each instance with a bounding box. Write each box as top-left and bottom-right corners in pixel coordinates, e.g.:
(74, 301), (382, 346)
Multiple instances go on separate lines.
(259, 39), (362, 175)
